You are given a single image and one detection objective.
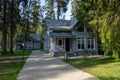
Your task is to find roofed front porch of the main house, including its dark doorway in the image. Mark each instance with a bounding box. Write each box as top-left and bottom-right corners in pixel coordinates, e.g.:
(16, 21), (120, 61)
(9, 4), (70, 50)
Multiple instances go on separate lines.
(50, 33), (76, 56)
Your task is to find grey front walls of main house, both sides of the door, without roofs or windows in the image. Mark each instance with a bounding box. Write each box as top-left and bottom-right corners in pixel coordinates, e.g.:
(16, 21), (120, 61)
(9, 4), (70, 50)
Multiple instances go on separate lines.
(44, 20), (97, 55)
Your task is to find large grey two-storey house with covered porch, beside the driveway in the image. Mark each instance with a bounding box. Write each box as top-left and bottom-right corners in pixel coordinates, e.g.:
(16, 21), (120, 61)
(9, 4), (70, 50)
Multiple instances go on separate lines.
(43, 19), (98, 56)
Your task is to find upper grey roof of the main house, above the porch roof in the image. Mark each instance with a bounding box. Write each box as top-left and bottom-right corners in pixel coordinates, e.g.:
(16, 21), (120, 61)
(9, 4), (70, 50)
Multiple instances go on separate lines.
(44, 19), (78, 30)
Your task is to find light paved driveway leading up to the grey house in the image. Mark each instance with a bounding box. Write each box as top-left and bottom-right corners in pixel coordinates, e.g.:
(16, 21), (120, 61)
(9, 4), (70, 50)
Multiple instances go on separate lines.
(17, 51), (98, 80)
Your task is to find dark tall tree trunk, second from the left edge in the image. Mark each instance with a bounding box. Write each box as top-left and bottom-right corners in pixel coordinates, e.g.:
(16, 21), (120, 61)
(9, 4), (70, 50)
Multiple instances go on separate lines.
(10, 0), (15, 53)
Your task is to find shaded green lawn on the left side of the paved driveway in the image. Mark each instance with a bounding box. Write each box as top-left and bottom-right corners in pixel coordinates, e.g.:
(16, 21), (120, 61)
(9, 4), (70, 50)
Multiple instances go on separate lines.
(0, 51), (31, 80)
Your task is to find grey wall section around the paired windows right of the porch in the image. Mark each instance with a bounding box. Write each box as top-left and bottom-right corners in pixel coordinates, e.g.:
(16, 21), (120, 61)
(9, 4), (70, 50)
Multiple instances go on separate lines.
(73, 27), (97, 54)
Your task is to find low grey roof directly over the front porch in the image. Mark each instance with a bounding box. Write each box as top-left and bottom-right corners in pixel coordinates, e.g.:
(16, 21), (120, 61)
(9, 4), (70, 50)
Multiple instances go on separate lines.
(50, 33), (75, 38)
